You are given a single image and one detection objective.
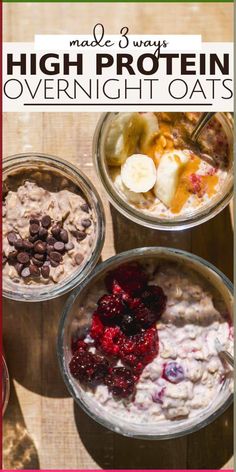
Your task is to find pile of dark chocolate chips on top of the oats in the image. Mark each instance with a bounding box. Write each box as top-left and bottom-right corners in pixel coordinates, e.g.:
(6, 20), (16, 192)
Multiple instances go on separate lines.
(3, 215), (83, 279)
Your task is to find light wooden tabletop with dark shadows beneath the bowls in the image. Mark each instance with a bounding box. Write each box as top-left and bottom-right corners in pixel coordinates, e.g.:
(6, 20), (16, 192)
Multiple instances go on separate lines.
(3, 3), (233, 469)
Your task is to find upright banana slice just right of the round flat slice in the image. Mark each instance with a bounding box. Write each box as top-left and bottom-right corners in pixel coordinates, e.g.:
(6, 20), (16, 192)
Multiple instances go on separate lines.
(154, 151), (190, 207)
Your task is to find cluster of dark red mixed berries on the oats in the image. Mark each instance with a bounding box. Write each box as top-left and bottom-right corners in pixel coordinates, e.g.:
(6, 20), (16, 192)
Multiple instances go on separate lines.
(70, 262), (167, 398)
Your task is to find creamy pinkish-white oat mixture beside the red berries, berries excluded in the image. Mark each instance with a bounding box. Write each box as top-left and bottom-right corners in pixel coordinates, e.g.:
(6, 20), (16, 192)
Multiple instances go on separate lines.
(71, 263), (233, 424)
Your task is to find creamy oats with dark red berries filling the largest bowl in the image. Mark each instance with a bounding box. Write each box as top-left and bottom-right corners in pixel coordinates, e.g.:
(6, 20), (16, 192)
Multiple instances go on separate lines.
(69, 260), (233, 425)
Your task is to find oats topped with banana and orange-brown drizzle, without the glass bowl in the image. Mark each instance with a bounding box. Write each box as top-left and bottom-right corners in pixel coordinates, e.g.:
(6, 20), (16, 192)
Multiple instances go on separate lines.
(104, 112), (231, 220)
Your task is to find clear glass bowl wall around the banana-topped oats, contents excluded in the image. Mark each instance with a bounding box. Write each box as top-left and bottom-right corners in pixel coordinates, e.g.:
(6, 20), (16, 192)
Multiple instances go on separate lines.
(93, 113), (233, 231)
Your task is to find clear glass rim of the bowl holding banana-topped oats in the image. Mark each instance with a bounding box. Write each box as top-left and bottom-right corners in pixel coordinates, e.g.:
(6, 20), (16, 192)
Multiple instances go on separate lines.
(93, 112), (233, 231)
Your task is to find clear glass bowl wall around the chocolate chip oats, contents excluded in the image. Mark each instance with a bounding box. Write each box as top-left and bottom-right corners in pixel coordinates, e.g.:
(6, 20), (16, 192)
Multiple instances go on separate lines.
(3, 153), (105, 302)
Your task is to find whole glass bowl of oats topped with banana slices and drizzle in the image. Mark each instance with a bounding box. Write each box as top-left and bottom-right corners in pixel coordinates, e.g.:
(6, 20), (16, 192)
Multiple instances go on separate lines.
(93, 112), (233, 230)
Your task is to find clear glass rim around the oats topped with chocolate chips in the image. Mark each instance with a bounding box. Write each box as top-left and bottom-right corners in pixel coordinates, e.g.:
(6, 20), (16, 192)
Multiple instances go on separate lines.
(2, 152), (105, 302)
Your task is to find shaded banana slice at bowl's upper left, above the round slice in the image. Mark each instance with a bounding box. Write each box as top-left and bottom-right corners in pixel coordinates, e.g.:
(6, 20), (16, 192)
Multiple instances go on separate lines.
(105, 112), (143, 166)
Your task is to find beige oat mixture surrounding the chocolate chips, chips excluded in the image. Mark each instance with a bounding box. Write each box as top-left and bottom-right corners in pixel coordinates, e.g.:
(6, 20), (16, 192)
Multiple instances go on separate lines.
(3, 181), (95, 285)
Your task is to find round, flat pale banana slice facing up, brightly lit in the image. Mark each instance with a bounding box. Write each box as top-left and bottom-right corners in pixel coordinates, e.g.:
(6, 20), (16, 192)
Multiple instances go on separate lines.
(121, 154), (156, 193)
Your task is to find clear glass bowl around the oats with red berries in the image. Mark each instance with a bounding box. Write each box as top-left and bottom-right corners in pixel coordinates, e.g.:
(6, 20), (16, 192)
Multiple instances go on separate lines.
(57, 247), (233, 439)
